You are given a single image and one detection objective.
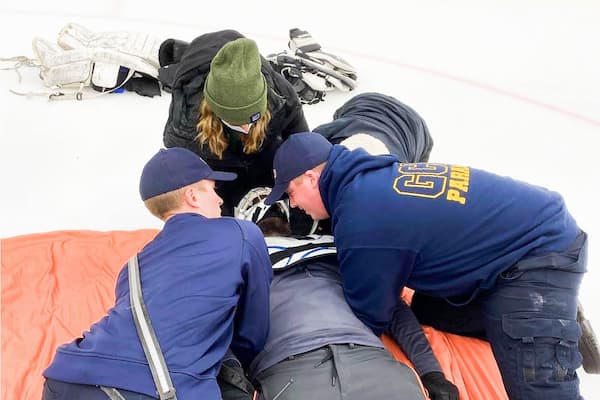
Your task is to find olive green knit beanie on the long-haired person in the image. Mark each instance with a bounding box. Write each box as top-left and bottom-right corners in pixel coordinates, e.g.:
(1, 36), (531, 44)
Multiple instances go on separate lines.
(204, 38), (267, 125)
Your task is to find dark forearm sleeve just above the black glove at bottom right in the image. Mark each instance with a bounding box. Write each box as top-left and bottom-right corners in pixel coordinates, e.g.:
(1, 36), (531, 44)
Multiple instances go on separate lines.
(388, 300), (442, 376)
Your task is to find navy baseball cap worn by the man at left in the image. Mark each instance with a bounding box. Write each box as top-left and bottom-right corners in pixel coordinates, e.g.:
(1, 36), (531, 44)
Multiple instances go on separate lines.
(140, 147), (237, 201)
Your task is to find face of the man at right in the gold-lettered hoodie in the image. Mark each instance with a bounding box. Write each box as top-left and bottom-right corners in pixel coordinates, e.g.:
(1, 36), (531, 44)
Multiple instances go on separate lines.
(287, 173), (329, 220)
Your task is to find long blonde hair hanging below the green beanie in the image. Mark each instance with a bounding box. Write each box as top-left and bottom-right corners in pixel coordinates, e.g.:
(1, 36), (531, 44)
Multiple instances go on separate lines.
(196, 99), (271, 159)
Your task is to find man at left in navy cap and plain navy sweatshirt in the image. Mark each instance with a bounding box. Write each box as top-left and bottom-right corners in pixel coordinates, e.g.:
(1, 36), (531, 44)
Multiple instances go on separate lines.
(43, 147), (272, 400)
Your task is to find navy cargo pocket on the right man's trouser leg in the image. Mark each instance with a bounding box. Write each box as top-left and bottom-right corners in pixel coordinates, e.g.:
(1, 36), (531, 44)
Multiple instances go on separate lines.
(502, 313), (582, 385)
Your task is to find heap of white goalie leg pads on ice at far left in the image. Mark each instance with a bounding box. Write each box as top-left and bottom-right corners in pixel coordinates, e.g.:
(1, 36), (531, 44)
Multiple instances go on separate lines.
(3, 23), (162, 100)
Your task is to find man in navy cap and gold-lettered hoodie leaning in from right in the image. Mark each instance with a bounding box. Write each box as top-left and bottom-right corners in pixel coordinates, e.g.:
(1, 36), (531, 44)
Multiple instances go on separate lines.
(265, 132), (587, 400)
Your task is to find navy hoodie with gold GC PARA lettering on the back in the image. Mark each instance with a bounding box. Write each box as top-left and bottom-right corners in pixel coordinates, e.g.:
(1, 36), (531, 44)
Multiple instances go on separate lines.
(319, 145), (578, 334)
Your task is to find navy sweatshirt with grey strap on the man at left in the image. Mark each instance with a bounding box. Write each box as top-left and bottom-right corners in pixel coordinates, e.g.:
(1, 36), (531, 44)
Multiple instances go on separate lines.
(44, 214), (272, 399)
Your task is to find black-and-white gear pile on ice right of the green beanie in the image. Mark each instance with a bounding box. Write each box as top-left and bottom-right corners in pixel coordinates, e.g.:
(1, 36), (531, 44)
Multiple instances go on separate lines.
(267, 28), (357, 104)
